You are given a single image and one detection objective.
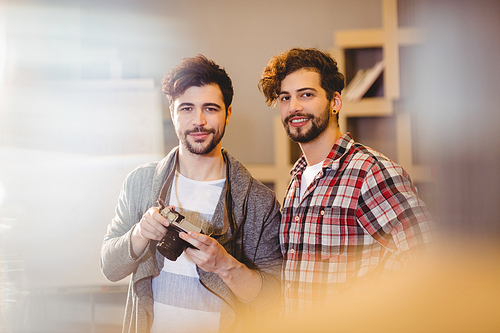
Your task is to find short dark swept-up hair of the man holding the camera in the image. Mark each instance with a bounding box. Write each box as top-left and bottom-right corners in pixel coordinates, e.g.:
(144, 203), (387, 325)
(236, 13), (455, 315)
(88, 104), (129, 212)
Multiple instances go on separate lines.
(161, 54), (234, 112)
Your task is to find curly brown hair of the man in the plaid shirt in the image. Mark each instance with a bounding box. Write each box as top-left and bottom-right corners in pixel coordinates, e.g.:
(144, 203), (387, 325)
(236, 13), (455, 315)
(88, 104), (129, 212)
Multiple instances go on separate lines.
(259, 48), (345, 105)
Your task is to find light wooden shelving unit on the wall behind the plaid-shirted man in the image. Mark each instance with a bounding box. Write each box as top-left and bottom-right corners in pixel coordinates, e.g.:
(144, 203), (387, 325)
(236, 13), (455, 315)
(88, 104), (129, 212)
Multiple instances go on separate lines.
(330, 0), (431, 183)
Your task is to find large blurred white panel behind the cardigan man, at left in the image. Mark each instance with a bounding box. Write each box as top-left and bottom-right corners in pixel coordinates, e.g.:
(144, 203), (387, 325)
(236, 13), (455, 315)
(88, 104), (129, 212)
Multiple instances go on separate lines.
(0, 80), (164, 288)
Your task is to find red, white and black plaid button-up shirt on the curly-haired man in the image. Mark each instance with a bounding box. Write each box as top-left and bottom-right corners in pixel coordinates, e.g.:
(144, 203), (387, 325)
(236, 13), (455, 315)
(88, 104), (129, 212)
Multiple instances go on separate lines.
(280, 134), (431, 315)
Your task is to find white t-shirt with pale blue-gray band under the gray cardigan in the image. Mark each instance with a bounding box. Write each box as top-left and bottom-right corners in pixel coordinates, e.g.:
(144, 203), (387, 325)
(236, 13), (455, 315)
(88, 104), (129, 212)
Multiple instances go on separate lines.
(151, 172), (225, 333)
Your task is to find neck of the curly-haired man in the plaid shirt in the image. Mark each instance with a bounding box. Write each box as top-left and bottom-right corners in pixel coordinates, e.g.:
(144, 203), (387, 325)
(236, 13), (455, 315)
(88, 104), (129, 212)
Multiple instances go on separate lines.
(300, 126), (342, 165)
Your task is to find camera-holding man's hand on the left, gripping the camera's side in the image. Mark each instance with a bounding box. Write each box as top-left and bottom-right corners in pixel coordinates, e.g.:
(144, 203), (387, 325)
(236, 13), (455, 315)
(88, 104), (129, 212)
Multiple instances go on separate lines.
(131, 206), (174, 258)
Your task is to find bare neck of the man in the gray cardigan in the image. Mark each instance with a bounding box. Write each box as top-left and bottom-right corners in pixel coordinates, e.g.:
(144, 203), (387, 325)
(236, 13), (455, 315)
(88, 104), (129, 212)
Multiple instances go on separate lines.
(177, 146), (226, 181)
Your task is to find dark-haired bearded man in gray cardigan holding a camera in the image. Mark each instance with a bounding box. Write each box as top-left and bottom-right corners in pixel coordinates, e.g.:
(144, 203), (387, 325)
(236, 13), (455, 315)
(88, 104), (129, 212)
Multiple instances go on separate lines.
(101, 55), (282, 332)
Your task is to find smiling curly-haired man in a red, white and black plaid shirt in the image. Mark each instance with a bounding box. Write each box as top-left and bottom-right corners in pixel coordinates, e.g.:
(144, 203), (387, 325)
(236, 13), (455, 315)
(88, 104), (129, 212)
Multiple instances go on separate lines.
(259, 48), (431, 315)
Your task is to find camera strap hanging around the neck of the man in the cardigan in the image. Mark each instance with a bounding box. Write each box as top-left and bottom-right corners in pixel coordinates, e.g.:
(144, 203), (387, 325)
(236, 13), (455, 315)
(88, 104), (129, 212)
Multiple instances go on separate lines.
(156, 151), (231, 239)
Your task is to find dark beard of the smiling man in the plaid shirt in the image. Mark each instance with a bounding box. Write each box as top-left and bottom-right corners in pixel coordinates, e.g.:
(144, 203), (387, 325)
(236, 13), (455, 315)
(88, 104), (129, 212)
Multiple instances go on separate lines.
(282, 105), (330, 143)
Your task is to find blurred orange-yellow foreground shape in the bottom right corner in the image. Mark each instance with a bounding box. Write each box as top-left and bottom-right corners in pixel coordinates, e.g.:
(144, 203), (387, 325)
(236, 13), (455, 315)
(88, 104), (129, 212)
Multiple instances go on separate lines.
(258, 242), (500, 333)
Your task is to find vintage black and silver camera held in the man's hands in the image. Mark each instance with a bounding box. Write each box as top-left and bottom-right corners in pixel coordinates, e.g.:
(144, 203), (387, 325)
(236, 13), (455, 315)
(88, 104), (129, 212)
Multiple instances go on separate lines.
(156, 208), (201, 261)
